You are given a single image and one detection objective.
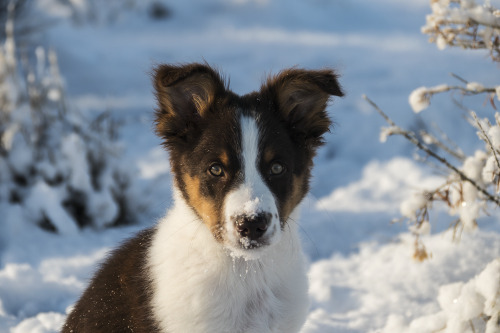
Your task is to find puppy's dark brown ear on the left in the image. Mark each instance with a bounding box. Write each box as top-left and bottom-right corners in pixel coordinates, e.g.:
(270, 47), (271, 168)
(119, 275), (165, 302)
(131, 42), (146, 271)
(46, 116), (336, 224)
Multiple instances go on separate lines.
(153, 63), (225, 145)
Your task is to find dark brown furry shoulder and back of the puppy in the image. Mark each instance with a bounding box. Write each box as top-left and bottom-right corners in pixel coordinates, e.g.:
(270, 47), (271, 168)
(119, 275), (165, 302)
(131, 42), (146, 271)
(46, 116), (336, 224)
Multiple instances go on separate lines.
(62, 228), (158, 333)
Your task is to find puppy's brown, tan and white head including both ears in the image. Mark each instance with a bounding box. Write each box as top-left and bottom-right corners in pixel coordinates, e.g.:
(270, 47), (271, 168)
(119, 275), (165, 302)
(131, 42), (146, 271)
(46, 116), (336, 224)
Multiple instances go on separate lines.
(154, 64), (342, 257)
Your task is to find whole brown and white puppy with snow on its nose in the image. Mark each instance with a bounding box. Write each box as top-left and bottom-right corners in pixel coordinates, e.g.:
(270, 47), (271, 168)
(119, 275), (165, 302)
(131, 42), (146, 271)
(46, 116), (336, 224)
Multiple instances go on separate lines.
(62, 63), (343, 333)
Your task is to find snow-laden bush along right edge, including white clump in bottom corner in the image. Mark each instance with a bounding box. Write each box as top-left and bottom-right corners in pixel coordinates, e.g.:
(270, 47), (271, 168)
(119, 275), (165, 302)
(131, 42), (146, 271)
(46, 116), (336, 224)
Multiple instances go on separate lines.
(365, 0), (500, 326)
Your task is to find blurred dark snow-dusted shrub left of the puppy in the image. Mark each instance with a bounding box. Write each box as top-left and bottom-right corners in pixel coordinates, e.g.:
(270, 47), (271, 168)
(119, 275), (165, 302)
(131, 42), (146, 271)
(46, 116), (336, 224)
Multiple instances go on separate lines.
(0, 2), (143, 233)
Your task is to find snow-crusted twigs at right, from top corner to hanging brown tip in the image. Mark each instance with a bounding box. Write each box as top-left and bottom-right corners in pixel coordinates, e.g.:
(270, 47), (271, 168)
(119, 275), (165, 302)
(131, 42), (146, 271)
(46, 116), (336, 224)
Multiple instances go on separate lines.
(365, 0), (500, 254)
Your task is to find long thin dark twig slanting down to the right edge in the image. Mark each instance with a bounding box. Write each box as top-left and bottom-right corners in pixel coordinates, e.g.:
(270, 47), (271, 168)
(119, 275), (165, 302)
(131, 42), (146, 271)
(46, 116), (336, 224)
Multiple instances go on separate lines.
(363, 95), (500, 206)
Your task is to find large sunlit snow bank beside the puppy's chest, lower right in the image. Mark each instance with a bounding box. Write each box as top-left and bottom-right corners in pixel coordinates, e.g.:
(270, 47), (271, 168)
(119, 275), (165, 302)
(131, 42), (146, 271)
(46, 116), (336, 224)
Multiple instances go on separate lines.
(304, 231), (500, 333)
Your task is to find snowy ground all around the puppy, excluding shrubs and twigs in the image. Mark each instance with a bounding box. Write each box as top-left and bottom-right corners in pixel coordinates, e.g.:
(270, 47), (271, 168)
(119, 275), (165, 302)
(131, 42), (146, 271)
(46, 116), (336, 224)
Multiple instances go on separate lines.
(0, 0), (500, 333)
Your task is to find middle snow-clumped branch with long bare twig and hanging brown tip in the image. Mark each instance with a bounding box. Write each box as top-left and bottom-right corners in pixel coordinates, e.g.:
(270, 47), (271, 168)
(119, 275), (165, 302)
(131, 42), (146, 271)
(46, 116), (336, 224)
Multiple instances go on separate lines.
(363, 92), (500, 261)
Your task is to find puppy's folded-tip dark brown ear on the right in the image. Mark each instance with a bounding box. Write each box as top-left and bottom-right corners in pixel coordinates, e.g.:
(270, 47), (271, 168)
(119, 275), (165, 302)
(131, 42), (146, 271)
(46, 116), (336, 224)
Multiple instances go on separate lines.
(261, 68), (344, 148)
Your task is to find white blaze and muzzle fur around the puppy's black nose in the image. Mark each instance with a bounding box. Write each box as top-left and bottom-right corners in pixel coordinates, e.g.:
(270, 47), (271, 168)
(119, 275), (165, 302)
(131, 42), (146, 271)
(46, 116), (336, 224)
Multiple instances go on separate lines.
(224, 116), (281, 254)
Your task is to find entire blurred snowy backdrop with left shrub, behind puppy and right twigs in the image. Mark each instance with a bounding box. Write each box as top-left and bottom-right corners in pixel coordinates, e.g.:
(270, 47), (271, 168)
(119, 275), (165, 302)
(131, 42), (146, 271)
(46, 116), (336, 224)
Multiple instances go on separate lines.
(0, 0), (500, 333)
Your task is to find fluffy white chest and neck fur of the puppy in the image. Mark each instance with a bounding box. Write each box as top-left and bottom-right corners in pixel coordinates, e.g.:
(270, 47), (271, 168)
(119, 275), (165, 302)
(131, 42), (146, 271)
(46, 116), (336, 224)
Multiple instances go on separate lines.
(148, 198), (309, 333)
